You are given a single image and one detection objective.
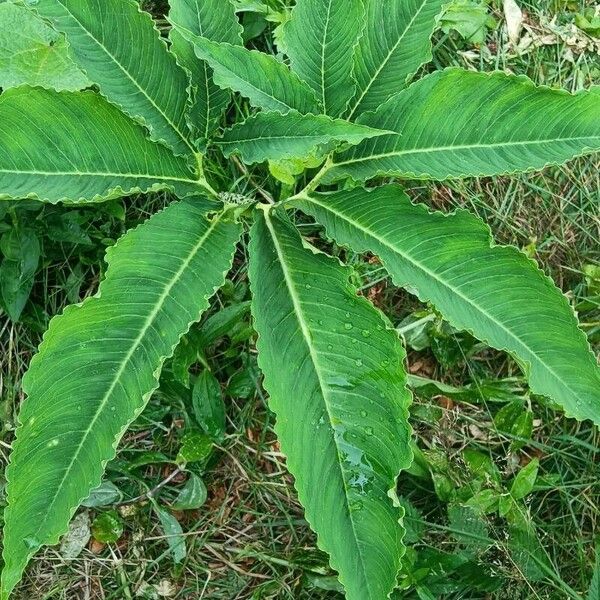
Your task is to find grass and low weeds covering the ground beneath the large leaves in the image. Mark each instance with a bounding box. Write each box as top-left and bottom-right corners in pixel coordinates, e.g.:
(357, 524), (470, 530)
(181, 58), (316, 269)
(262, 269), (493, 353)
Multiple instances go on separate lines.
(0, 0), (600, 600)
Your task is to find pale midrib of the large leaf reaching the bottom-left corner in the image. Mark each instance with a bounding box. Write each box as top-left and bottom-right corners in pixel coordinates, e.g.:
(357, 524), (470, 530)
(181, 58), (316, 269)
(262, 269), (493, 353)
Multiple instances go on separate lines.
(26, 215), (222, 538)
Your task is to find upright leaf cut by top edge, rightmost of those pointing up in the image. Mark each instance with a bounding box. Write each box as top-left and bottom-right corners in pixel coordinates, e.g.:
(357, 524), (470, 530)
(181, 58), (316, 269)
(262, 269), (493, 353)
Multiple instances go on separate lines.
(350, 0), (445, 116)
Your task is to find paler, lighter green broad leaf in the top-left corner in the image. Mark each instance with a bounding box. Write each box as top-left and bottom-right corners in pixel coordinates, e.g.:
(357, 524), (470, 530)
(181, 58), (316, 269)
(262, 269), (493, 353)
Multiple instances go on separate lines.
(0, 2), (90, 90)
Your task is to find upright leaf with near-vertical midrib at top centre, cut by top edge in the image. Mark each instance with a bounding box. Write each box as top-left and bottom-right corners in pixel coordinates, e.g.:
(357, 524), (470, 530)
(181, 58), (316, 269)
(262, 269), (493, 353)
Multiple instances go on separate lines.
(282, 0), (365, 117)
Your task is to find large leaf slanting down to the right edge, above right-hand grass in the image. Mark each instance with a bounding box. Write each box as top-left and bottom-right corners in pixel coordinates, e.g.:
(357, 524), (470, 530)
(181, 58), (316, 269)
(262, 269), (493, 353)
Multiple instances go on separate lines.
(300, 186), (600, 424)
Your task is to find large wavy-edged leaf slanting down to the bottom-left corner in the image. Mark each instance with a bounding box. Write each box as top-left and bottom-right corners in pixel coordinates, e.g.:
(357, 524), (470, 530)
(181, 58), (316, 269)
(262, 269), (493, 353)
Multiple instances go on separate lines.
(0, 199), (240, 600)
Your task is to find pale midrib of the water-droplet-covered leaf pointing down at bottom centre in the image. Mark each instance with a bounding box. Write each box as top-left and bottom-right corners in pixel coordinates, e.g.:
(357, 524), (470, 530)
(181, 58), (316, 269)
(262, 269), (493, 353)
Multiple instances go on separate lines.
(265, 211), (368, 596)
